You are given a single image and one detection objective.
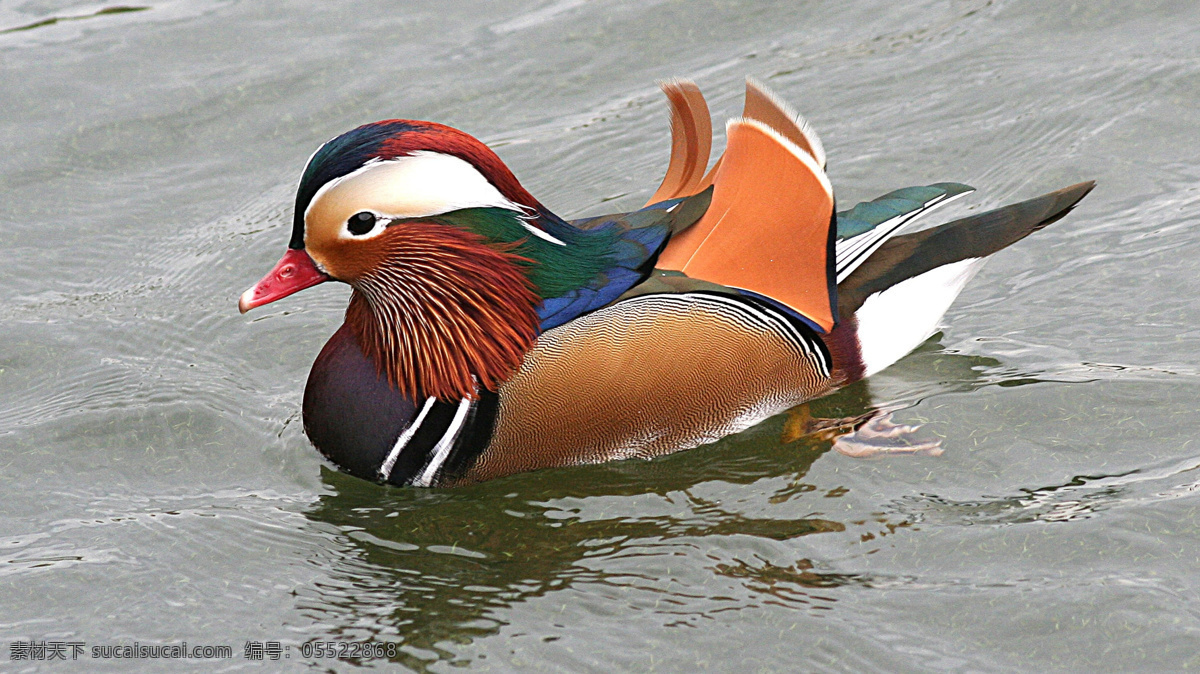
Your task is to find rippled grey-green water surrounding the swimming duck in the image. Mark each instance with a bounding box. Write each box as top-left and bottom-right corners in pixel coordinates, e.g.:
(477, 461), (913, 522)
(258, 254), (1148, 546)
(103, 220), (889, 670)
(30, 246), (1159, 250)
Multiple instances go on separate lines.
(0, 0), (1200, 672)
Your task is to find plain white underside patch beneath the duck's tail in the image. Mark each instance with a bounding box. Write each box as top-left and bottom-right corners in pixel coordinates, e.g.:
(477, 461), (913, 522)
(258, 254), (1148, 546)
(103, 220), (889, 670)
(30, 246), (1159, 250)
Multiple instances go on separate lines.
(854, 258), (986, 377)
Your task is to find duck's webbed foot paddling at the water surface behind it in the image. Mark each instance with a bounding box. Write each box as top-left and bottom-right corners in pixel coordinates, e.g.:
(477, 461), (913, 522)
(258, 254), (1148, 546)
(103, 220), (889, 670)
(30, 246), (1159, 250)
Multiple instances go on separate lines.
(782, 405), (942, 458)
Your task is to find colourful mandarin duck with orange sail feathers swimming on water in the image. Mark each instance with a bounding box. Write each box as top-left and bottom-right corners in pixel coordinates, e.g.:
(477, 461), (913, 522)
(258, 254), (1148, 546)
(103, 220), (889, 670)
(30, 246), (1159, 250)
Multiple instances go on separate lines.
(239, 79), (1093, 487)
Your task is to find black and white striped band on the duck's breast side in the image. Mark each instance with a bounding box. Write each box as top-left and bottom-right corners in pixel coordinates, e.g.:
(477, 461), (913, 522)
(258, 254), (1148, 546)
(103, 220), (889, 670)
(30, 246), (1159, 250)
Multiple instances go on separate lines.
(378, 391), (499, 487)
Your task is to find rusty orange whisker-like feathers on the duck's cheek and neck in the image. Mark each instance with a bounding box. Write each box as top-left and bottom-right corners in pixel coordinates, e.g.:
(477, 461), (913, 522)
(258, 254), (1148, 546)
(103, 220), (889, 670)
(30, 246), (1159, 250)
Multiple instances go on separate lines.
(346, 222), (540, 401)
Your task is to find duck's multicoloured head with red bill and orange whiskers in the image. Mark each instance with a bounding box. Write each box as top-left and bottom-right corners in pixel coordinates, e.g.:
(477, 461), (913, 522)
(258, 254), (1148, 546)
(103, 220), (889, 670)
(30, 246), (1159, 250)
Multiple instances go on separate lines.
(239, 120), (564, 401)
